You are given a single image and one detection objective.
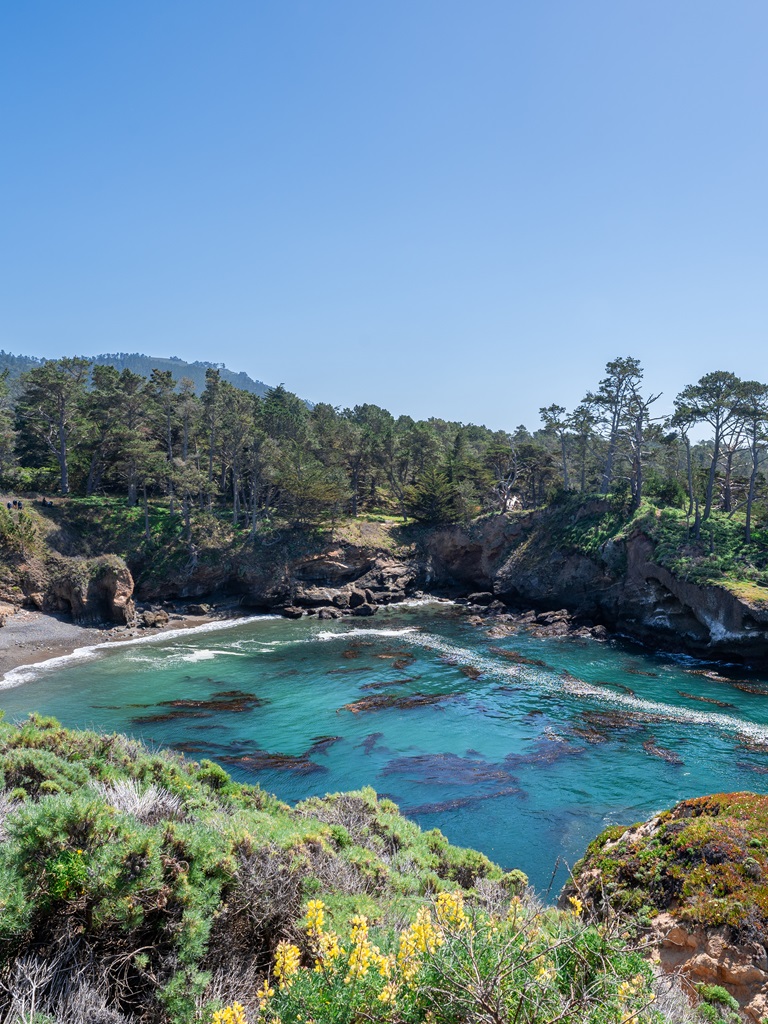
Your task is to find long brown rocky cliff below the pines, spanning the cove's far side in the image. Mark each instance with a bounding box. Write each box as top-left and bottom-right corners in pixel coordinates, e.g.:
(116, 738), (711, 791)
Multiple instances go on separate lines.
(0, 499), (768, 663)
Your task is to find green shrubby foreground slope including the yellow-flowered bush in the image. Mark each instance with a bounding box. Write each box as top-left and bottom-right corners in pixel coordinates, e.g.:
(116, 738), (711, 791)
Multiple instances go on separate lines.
(0, 716), (704, 1024)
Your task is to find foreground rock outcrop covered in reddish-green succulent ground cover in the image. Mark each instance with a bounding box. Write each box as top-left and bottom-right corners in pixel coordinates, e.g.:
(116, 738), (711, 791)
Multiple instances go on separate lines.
(561, 793), (768, 1022)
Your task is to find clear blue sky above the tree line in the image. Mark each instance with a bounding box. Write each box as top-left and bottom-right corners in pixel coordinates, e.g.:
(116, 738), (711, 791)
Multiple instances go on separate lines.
(0, 0), (768, 428)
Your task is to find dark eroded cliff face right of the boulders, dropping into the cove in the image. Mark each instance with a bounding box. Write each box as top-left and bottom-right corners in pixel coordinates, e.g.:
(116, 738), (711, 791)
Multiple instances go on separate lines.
(428, 510), (768, 662)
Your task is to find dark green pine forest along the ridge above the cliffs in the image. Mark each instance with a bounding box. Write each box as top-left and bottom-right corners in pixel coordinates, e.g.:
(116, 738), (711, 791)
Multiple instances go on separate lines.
(0, 356), (768, 598)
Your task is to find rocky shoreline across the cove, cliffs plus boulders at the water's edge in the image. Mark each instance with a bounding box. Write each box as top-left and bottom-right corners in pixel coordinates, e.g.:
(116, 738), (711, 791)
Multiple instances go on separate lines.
(0, 501), (768, 670)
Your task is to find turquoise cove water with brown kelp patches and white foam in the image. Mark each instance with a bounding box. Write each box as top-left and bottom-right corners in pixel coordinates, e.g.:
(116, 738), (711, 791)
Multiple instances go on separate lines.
(0, 603), (768, 893)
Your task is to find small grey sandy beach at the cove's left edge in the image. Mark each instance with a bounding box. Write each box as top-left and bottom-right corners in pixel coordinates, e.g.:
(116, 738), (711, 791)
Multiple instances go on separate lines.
(0, 608), (233, 681)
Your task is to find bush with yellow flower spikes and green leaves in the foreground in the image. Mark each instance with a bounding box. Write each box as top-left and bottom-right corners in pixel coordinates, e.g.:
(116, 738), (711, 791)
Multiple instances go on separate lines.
(208, 890), (663, 1024)
